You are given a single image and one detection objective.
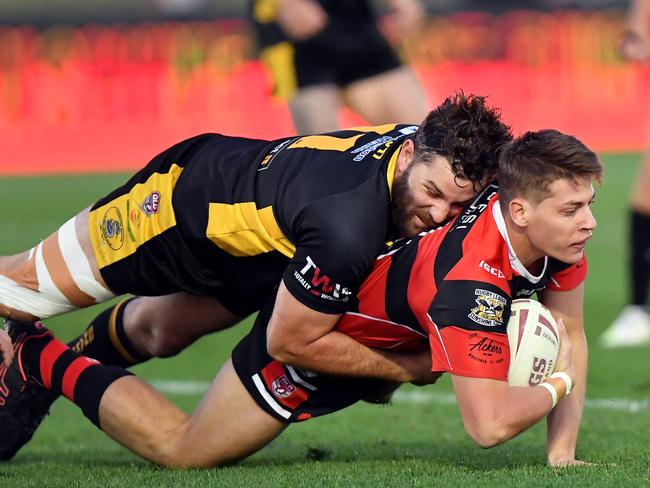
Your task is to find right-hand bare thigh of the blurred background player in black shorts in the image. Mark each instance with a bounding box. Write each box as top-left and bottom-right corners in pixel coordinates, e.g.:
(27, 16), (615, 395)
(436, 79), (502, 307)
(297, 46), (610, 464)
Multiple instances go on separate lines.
(342, 66), (428, 124)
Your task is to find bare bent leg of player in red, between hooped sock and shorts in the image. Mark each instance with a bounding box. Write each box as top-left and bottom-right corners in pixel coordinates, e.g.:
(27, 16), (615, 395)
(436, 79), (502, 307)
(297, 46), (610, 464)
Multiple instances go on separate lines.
(99, 361), (286, 468)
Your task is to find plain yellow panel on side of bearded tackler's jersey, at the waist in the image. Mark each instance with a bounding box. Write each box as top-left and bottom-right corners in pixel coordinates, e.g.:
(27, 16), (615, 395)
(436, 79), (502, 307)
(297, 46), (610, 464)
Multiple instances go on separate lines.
(206, 202), (296, 257)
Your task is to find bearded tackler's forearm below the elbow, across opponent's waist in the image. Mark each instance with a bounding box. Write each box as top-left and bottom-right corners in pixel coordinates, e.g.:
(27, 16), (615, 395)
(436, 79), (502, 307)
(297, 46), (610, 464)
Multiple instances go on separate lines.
(272, 331), (415, 383)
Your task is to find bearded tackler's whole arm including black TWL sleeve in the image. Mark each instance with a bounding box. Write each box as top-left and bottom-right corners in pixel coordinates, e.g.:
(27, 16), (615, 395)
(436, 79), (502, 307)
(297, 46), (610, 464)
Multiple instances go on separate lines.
(267, 191), (434, 383)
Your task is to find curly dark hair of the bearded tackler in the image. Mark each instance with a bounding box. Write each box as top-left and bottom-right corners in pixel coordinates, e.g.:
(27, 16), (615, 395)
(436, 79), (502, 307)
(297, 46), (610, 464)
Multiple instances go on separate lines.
(413, 92), (512, 186)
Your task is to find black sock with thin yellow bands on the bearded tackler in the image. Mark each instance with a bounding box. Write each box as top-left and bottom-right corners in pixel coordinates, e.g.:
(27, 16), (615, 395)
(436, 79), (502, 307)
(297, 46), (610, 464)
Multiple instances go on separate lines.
(68, 298), (150, 368)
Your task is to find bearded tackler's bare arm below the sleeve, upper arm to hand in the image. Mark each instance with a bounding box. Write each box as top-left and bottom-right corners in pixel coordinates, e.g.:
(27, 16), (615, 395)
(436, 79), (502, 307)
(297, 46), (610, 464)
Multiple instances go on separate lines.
(267, 283), (434, 383)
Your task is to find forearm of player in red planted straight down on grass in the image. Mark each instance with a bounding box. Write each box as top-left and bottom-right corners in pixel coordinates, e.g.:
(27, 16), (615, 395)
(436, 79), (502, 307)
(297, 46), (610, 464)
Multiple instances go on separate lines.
(547, 328), (588, 464)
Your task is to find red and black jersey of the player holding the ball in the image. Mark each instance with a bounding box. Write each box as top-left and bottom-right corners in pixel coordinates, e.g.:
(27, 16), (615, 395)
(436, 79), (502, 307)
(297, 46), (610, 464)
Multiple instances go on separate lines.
(337, 185), (587, 380)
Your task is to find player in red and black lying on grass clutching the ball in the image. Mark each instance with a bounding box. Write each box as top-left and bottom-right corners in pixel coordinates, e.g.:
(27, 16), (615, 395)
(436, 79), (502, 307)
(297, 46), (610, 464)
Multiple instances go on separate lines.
(0, 131), (602, 467)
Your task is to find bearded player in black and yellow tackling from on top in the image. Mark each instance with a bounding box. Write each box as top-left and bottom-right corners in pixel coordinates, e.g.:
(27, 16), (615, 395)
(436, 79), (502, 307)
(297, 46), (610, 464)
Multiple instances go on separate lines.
(0, 94), (511, 454)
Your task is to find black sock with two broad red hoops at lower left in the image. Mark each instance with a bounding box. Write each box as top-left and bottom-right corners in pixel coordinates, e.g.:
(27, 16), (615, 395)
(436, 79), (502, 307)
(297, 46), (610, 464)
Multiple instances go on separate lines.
(20, 334), (131, 428)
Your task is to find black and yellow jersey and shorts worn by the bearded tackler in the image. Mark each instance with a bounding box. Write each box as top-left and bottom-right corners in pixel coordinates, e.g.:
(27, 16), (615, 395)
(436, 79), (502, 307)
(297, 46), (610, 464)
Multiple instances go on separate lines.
(89, 124), (417, 313)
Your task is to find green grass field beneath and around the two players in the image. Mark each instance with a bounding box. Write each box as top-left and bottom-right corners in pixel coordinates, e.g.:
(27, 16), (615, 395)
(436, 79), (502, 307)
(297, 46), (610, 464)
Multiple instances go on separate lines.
(0, 155), (650, 487)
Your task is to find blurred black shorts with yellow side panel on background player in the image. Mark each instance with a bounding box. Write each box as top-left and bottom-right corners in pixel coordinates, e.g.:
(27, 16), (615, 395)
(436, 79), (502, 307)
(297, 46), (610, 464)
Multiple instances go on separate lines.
(260, 18), (402, 99)
